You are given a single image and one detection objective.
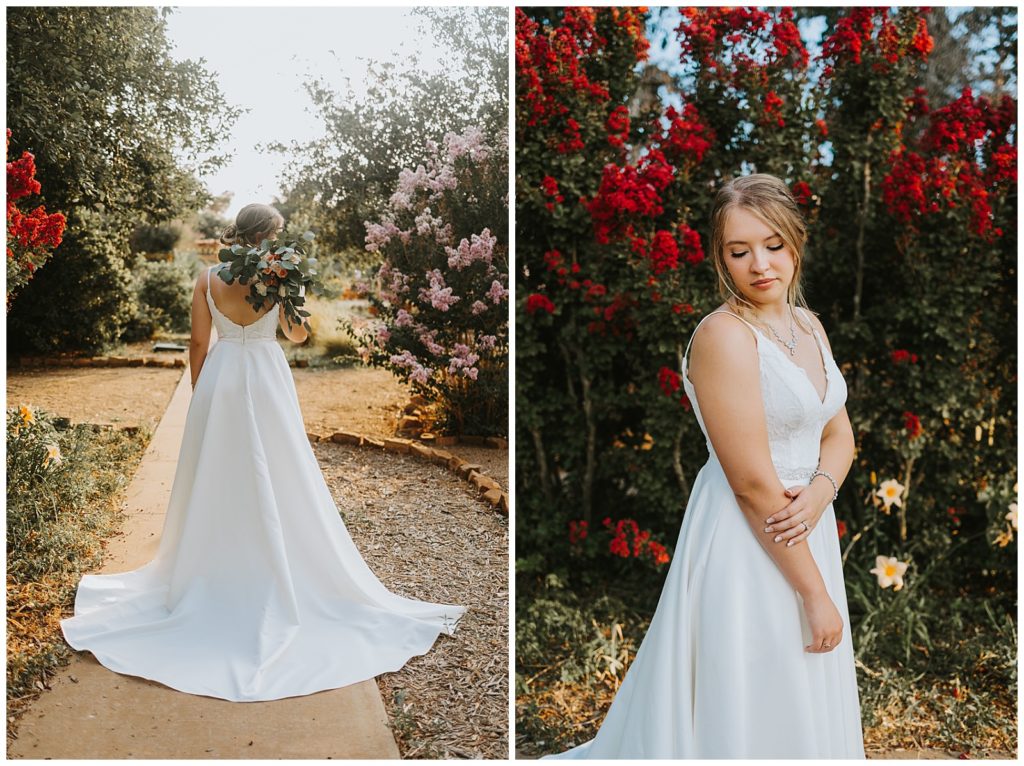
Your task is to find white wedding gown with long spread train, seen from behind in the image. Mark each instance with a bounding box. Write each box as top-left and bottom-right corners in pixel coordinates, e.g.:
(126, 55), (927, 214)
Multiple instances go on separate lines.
(60, 267), (465, 701)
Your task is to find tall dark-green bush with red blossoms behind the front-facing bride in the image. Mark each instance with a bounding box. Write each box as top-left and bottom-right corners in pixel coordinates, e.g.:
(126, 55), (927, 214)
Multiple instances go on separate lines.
(516, 6), (1018, 746)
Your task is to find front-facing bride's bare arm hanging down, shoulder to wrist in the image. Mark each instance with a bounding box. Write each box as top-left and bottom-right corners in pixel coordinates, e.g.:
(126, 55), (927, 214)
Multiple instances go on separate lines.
(687, 315), (825, 599)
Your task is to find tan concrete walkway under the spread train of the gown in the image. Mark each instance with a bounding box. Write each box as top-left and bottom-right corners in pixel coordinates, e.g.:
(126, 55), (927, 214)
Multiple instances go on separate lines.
(7, 368), (399, 759)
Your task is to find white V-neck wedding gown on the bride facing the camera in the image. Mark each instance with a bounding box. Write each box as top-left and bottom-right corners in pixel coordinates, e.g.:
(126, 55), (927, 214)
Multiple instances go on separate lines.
(550, 311), (864, 759)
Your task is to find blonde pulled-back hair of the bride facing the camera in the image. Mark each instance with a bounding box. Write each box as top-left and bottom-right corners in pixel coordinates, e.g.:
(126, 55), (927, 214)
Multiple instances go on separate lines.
(709, 173), (813, 332)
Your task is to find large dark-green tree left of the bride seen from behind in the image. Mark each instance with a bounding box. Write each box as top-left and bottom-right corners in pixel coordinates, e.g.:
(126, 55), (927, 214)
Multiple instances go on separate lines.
(7, 6), (240, 350)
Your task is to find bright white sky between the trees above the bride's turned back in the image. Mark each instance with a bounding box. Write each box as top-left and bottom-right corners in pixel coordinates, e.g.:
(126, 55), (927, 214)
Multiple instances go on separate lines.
(167, 7), (448, 218)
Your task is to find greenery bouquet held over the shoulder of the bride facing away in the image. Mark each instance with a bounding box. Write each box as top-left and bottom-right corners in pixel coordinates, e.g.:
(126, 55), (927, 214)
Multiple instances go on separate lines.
(217, 231), (327, 332)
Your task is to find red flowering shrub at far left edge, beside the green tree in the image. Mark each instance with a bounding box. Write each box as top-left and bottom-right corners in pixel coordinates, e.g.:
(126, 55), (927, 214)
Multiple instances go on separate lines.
(7, 129), (67, 309)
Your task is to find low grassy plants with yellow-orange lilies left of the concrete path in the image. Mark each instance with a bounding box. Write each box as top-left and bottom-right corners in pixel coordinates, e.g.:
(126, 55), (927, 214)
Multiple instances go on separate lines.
(7, 405), (150, 698)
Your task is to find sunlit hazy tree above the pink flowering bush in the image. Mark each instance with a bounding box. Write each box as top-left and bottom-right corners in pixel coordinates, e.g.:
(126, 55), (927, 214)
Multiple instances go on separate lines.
(271, 7), (508, 260)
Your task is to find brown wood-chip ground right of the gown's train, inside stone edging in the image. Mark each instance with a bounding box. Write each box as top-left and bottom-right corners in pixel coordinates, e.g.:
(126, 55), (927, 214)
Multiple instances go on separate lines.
(315, 442), (509, 759)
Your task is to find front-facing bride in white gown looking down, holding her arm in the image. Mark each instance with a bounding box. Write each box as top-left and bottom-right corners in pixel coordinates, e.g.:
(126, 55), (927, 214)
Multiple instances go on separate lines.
(555, 174), (864, 759)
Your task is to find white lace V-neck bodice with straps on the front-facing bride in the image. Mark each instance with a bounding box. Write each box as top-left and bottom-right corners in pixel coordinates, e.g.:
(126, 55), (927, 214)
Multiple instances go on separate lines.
(682, 311), (847, 482)
